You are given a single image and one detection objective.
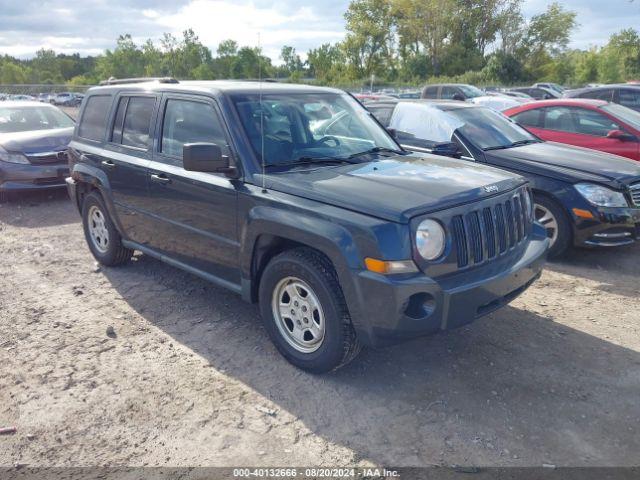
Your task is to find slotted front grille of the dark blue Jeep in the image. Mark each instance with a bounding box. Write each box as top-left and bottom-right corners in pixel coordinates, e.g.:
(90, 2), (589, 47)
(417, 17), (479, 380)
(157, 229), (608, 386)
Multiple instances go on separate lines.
(452, 185), (528, 268)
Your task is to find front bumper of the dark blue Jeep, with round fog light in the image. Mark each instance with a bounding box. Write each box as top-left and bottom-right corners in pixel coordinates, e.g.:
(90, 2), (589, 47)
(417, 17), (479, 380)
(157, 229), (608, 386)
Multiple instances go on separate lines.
(349, 228), (549, 346)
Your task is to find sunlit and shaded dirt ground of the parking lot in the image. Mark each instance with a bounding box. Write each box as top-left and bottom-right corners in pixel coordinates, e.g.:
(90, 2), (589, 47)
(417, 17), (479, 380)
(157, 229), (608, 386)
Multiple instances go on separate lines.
(0, 189), (640, 466)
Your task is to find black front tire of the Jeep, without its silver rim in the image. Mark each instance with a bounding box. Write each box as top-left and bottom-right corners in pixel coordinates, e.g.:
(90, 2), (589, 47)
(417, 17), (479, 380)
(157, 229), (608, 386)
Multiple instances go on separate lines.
(259, 247), (361, 373)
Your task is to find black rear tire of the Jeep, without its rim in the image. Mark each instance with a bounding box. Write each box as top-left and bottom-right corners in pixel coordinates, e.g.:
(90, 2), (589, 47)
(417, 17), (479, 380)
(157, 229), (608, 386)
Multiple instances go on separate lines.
(82, 192), (133, 267)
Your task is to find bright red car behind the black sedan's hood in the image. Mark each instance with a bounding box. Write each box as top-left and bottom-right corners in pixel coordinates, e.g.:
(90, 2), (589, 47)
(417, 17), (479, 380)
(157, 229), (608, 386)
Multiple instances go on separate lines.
(503, 98), (640, 160)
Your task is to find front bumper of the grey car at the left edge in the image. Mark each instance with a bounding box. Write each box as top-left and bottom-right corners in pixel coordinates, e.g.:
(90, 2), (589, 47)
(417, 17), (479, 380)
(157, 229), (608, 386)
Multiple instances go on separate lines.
(0, 162), (69, 192)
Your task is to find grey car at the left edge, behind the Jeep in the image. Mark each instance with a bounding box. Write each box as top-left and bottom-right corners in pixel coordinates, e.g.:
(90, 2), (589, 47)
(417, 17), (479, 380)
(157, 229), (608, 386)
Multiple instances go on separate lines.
(0, 101), (75, 201)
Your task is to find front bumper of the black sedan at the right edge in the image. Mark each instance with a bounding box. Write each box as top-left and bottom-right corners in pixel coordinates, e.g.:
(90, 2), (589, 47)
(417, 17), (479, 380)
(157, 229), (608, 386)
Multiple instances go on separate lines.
(573, 207), (640, 247)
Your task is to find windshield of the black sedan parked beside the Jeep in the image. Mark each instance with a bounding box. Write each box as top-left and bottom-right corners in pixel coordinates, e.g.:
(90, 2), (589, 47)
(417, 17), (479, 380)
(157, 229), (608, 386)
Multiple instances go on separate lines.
(447, 107), (539, 150)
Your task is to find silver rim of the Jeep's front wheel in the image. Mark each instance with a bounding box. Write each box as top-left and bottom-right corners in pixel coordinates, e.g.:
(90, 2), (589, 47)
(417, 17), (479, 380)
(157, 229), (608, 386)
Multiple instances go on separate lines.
(271, 277), (325, 353)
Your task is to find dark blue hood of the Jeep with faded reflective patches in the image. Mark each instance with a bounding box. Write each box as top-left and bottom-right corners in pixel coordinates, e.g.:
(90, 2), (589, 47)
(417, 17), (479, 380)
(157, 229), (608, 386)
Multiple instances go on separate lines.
(266, 154), (526, 223)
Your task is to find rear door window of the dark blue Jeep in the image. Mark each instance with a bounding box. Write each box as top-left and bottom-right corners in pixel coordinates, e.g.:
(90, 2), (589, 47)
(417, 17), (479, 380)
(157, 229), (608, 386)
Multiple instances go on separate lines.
(111, 97), (156, 148)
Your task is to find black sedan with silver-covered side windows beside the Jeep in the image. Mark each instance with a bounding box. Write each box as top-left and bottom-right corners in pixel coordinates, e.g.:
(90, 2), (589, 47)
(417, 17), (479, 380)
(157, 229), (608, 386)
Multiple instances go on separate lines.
(366, 100), (640, 257)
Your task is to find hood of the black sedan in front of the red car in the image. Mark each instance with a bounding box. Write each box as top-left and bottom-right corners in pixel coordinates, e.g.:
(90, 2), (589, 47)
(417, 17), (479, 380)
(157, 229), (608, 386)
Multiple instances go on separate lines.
(485, 142), (640, 184)
